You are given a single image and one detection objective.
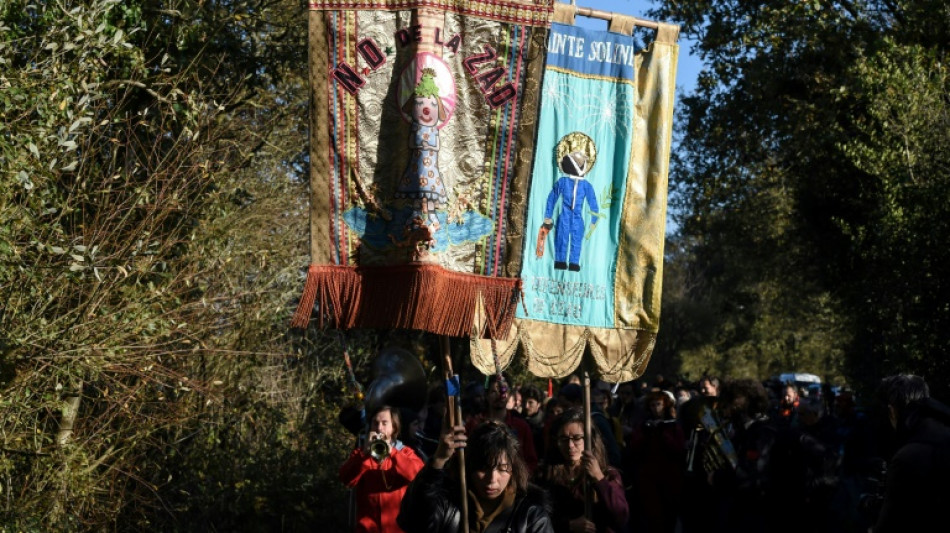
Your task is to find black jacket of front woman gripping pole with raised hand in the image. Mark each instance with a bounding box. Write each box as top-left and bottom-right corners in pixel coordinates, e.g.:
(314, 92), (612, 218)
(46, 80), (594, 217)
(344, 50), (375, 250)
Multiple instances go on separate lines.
(396, 465), (554, 533)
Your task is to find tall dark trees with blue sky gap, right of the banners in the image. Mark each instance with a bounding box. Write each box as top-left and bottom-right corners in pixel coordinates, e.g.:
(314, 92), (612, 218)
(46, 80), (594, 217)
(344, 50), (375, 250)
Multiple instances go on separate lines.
(653, 0), (950, 398)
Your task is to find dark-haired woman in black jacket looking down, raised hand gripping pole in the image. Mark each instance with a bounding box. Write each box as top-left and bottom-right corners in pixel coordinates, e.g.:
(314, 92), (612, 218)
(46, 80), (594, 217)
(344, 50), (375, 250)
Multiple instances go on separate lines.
(397, 417), (553, 533)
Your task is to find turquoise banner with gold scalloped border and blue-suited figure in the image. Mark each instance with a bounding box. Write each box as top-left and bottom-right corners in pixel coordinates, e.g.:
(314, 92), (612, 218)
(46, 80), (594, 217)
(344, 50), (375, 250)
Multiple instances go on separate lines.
(472, 15), (679, 382)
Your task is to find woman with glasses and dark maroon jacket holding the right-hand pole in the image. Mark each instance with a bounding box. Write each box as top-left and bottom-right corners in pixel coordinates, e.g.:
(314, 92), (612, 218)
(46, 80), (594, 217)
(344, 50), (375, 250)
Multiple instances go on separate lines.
(538, 407), (630, 533)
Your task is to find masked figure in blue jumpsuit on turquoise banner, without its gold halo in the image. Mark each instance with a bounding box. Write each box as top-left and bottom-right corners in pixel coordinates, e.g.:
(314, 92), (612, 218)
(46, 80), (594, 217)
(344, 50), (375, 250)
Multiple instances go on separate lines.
(544, 152), (600, 272)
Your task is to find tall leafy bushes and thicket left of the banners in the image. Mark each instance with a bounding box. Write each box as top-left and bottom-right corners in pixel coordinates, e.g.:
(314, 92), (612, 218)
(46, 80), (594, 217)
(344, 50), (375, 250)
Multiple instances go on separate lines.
(0, 0), (374, 531)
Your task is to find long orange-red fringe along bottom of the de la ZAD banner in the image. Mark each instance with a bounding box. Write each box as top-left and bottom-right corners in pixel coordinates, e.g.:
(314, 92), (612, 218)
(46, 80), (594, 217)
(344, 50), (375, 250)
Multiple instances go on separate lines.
(291, 263), (521, 338)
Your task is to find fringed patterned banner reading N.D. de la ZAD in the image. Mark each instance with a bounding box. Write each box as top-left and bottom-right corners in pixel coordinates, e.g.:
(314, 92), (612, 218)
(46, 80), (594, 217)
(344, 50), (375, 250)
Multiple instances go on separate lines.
(292, 0), (553, 336)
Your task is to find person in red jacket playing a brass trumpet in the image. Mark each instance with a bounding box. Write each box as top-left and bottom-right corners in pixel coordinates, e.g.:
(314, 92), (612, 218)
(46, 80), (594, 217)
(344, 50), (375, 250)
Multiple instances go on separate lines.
(340, 406), (424, 533)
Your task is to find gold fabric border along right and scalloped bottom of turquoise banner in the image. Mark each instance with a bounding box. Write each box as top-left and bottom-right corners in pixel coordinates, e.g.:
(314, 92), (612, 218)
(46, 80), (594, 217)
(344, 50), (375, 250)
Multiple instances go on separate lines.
(471, 24), (679, 383)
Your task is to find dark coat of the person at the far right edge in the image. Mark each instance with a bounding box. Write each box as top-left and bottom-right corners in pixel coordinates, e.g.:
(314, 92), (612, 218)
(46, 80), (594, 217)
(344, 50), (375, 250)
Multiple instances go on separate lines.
(874, 398), (950, 533)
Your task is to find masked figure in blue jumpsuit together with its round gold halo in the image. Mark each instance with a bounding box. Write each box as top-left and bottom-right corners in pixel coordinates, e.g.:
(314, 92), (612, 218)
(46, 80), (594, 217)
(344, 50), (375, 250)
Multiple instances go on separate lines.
(539, 132), (600, 272)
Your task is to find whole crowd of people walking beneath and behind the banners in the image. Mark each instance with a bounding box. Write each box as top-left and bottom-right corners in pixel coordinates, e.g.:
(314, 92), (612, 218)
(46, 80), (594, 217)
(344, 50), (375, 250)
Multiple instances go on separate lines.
(340, 374), (950, 533)
